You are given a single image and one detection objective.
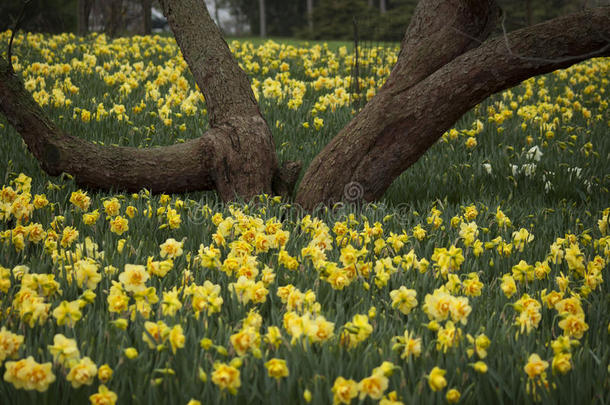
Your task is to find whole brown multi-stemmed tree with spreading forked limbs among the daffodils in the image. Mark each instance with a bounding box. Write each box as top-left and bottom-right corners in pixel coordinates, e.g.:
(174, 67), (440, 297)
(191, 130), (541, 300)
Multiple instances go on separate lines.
(0, 0), (610, 209)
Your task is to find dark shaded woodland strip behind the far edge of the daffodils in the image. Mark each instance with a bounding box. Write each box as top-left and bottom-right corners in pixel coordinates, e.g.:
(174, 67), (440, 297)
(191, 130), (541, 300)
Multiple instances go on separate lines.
(0, 0), (610, 41)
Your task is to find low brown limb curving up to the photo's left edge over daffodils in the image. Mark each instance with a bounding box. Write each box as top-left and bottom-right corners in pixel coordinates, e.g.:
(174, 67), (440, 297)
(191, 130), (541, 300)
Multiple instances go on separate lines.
(0, 57), (214, 193)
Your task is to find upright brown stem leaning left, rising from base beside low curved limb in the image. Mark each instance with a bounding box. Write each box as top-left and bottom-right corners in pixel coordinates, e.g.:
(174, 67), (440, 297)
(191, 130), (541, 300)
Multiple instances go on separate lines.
(161, 0), (279, 200)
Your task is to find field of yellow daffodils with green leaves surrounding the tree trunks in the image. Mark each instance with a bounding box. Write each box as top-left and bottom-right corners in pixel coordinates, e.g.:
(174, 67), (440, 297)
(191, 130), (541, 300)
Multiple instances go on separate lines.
(0, 32), (610, 405)
